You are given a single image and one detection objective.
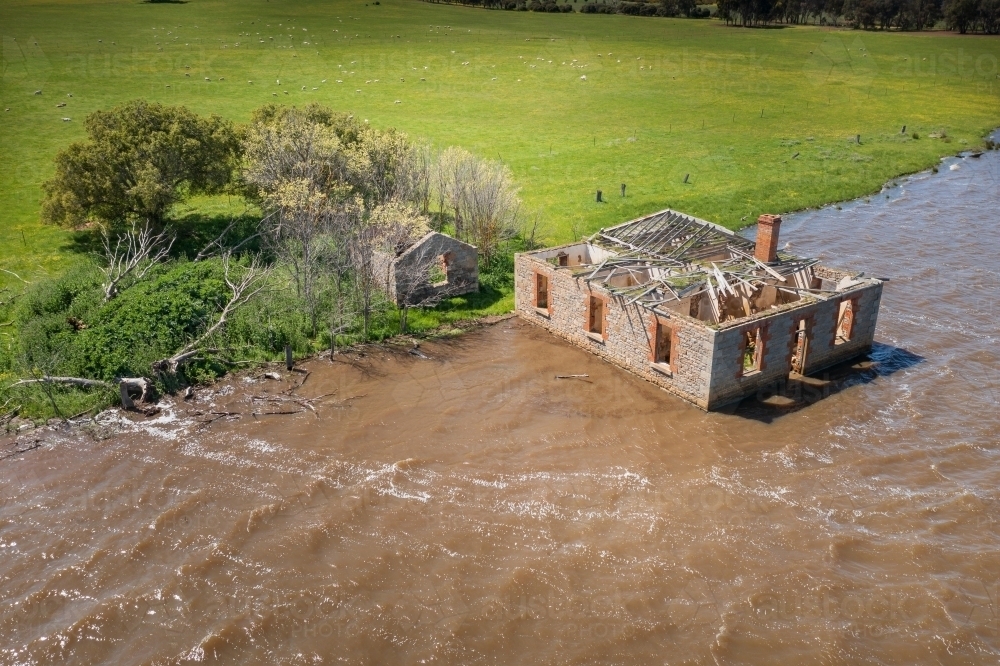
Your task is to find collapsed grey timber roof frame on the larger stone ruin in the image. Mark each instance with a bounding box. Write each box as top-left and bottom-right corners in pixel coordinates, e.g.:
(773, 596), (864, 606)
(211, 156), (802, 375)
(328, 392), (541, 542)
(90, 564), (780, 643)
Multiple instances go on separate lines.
(573, 208), (831, 312)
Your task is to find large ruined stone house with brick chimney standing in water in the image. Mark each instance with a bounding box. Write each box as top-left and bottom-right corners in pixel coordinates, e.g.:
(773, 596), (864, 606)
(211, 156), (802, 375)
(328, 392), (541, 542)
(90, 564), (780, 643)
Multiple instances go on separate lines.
(515, 210), (883, 410)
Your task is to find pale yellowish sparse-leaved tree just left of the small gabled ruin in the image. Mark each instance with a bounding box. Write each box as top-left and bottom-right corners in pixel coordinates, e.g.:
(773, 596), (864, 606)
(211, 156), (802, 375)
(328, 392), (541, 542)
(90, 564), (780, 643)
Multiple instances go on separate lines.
(243, 105), (431, 339)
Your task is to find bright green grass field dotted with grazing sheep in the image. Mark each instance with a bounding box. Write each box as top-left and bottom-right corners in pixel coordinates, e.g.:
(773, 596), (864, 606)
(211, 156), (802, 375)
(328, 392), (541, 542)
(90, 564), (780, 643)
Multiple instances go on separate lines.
(0, 0), (1000, 284)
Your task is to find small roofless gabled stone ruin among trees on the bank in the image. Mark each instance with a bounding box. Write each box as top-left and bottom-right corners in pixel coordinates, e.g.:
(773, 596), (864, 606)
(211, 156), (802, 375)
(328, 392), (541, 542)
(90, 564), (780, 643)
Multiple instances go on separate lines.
(374, 231), (479, 307)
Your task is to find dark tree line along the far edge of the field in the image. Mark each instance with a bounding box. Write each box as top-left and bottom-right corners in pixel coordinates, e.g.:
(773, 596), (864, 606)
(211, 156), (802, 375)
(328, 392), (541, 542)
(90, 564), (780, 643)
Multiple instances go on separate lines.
(425, 0), (1000, 35)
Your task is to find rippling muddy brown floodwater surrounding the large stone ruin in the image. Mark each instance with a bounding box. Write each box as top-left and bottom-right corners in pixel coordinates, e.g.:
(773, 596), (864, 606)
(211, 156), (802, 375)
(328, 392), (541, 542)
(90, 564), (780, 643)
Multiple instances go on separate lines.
(0, 147), (1000, 664)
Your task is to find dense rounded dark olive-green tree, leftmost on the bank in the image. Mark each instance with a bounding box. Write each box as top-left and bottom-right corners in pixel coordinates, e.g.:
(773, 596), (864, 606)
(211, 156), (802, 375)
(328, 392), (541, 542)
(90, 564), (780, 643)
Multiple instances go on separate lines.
(42, 100), (239, 229)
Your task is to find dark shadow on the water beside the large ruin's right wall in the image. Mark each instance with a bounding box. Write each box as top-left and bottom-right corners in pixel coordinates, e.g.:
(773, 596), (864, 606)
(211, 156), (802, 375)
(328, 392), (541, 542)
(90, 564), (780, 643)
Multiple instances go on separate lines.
(719, 342), (926, 423)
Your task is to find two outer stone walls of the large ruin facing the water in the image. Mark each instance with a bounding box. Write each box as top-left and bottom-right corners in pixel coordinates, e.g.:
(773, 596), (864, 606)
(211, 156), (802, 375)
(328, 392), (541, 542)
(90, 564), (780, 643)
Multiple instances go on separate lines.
(514, 254), (882, 409)
